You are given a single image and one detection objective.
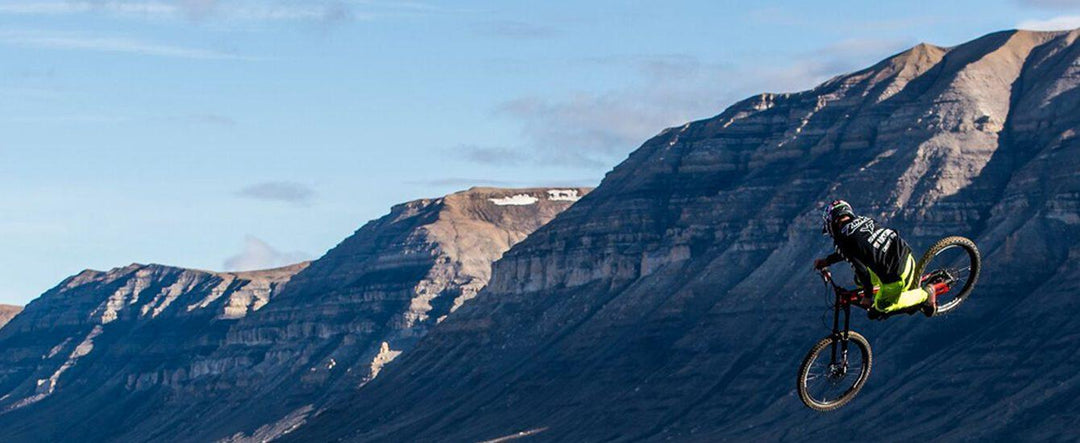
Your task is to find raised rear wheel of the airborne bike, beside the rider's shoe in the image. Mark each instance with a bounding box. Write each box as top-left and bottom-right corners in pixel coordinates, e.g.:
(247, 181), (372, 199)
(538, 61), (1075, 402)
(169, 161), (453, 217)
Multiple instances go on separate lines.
(916, 237), (982, 316)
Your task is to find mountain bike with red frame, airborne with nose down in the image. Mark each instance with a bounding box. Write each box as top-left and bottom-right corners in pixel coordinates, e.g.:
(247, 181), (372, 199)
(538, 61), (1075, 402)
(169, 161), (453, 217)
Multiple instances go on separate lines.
(797, 237), (982, 412)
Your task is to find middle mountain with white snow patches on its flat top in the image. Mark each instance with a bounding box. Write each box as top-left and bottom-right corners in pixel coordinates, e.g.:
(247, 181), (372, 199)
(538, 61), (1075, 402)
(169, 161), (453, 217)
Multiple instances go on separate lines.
(192, 188), (588, 440)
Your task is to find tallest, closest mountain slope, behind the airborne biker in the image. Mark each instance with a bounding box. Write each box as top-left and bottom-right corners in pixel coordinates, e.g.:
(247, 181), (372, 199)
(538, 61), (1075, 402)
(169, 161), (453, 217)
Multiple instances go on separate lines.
(285, 30), (1080, 441)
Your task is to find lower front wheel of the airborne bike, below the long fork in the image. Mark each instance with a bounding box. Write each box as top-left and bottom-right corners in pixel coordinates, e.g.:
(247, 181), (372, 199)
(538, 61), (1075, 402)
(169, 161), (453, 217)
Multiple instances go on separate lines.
(798, 332), (872, 412)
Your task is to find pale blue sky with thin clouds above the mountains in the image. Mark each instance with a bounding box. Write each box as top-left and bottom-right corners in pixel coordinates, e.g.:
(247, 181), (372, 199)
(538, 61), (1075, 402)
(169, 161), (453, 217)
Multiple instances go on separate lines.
(0, 0), (1080, 305)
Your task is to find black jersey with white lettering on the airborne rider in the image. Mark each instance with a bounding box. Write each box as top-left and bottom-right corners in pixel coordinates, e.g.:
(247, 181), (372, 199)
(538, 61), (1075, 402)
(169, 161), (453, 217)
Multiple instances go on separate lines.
(826, 216), (912, 283)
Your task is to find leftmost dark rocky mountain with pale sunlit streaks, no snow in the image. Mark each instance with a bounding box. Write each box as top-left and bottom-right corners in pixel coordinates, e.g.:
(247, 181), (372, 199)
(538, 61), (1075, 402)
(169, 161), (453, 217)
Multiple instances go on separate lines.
(0, 264), (307, 441)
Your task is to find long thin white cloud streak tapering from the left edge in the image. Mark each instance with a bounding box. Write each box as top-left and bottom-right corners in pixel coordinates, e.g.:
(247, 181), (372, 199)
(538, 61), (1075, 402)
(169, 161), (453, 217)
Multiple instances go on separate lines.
(0, 30), (252, 59)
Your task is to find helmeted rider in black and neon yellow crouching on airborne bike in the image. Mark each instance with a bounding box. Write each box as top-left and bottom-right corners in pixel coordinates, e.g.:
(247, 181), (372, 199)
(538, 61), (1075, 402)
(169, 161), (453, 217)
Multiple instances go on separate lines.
(814, 200), (947, 318)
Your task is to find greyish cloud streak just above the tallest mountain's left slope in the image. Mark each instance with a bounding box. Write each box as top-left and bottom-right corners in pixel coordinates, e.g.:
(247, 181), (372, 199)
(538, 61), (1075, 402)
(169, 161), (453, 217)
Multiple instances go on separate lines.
(486, 40), (913, 169)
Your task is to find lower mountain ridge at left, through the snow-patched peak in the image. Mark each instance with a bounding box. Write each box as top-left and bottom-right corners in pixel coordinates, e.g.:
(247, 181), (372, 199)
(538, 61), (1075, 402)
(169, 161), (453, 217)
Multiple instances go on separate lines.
(0, 188), (589, 441)
